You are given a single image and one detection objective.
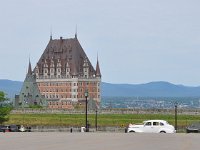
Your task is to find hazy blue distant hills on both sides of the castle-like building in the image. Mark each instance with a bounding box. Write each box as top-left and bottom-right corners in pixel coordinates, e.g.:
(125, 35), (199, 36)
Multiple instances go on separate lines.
(0, 80), (200, 98)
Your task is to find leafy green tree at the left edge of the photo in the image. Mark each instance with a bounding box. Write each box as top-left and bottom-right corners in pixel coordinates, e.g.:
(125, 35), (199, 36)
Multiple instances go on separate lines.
(0, 91), (11, 124)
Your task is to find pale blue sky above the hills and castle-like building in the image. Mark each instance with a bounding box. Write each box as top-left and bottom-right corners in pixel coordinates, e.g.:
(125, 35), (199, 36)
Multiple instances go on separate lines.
(0, 0), (200, 86)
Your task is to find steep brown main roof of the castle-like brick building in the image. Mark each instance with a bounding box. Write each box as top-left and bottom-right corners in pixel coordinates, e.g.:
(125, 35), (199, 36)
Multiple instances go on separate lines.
(34, 36), (96, 76)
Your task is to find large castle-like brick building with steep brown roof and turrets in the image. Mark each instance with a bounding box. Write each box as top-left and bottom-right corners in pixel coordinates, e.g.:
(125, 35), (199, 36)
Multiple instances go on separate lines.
(15, 35), (101, 109)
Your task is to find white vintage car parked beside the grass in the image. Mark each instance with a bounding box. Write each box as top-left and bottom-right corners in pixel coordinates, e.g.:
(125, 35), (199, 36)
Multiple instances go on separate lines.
(127, 120), (176, 133)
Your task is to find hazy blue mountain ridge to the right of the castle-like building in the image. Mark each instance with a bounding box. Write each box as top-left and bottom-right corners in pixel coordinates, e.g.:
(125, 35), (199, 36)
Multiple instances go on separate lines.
(102, 81), (200, 97)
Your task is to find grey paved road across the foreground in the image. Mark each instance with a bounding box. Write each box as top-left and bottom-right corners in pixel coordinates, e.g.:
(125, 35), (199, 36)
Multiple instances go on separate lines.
(0, 132), (200, 150)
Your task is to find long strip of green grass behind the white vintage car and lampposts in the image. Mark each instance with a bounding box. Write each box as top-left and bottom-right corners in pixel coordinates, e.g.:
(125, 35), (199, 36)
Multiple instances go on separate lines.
(4, 114), (200, 128)
